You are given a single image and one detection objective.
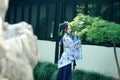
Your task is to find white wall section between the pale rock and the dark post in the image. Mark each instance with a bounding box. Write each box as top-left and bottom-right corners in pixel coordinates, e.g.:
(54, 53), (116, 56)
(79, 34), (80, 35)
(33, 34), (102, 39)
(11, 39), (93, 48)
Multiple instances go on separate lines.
(38, 40), (55, 63)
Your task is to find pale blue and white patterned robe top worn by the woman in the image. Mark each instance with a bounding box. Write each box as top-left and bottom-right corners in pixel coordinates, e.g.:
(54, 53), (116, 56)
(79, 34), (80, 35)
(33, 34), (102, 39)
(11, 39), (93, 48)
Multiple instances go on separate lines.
(58, 33), (82, 68)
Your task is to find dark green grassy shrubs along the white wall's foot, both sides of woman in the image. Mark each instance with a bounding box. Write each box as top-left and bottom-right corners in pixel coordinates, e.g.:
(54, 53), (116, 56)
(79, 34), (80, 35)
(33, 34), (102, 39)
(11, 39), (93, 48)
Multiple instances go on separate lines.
(33, 62), (115, 80)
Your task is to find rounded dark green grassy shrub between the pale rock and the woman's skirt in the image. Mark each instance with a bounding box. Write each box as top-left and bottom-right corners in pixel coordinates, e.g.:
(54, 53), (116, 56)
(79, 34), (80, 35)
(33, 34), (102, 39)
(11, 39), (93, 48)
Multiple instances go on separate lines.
(33, 62), (57, 80)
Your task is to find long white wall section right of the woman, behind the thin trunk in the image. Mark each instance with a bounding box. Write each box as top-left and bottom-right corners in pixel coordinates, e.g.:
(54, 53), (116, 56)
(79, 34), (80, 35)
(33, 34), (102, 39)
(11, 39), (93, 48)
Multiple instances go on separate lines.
(76, 45), (120, 78)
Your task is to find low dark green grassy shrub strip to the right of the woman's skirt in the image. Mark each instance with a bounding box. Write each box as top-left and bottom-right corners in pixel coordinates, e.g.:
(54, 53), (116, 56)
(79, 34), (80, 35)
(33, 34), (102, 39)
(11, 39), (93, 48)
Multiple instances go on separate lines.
(72, 70), (114, 80)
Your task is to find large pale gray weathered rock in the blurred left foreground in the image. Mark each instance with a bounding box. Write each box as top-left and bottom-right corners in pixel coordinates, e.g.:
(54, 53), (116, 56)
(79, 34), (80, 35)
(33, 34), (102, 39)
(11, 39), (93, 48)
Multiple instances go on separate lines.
(0, 0), (38, 80)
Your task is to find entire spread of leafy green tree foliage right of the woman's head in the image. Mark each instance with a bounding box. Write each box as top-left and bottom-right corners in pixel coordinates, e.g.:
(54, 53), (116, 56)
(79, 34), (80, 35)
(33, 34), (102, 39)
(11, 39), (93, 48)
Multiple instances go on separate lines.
(70, 14), (120, 44)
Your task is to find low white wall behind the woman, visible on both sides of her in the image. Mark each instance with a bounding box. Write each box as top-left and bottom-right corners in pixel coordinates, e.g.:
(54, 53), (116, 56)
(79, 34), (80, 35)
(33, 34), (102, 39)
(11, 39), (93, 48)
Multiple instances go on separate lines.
(38, 41), (120, 78)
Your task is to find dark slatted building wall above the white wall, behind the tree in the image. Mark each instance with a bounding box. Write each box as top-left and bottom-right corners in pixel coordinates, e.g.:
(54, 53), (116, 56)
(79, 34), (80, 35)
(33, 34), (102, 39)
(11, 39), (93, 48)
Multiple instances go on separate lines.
(6, 0), (120, 40)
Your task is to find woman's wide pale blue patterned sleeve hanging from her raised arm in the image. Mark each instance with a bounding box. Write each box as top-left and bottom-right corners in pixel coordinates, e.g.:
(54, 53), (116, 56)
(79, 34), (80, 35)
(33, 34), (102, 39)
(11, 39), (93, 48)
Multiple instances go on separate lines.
(63, 37), (82, 60)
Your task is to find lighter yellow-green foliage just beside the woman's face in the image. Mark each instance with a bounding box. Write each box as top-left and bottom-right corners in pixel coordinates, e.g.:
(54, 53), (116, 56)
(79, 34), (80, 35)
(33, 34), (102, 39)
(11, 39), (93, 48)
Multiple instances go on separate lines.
(70, 14), (99, 39)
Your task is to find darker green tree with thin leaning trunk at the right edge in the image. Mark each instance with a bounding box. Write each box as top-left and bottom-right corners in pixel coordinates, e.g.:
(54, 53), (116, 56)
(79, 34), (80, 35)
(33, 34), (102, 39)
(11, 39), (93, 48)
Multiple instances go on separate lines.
(86, 21), (120, 78)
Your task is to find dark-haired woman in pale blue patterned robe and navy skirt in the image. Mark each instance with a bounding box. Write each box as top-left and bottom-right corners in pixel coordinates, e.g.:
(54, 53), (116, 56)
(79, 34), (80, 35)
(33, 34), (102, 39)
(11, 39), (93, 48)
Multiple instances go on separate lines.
(56, 23), (82, 80)
